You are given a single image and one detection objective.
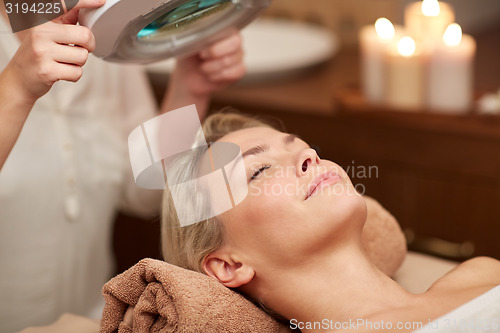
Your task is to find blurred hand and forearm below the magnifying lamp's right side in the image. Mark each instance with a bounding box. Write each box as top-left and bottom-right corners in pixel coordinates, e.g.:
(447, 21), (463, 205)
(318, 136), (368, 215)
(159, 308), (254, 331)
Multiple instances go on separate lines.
(161, 32), (246, 119)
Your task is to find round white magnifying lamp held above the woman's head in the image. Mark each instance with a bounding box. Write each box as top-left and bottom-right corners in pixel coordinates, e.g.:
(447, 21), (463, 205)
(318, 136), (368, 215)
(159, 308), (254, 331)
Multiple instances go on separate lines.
(79, 0), (271, 64)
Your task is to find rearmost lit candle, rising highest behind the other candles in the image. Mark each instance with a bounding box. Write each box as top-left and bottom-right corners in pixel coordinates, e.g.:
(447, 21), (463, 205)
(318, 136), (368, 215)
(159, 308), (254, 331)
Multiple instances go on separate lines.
(405, 0), (455, 52)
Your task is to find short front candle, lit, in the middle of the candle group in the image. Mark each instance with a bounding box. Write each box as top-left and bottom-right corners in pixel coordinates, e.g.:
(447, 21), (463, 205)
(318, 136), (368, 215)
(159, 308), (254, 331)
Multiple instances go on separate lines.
(385, 36), (425, 111)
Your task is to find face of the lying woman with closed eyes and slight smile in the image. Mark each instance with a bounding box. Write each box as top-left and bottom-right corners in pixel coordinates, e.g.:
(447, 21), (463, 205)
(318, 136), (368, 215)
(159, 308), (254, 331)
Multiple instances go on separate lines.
(219, 127), (366, 267)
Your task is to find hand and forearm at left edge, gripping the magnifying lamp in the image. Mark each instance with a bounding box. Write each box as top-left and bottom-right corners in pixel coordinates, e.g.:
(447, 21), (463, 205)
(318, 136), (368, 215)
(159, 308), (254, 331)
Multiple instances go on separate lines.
(0, 0), (104, 171)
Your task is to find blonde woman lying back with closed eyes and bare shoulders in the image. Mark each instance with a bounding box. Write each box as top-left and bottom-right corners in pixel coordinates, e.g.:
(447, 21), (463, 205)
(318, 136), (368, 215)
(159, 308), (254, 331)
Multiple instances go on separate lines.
(162, 113), (500, 332)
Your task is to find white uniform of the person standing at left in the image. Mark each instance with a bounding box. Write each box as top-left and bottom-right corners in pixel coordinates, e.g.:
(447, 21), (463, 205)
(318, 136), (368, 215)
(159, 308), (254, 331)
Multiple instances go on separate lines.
(0, 18), (161, 332)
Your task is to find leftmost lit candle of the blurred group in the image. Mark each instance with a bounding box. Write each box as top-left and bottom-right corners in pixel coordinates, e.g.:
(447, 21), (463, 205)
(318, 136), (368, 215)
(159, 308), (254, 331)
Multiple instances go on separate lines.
(359, 18), (402, 103)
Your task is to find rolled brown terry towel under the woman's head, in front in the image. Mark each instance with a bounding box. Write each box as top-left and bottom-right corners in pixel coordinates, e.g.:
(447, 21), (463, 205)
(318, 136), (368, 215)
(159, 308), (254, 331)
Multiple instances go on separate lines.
(100, 259), (291, 333)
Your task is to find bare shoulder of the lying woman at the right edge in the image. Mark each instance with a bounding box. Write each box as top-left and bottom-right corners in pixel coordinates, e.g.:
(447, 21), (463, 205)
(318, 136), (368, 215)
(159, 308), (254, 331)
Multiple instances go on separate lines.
(431, 257), (500, 288)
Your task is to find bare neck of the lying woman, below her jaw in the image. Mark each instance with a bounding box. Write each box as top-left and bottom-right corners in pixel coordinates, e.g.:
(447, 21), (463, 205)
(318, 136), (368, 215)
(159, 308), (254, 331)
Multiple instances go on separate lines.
(255, 243), (416, 332)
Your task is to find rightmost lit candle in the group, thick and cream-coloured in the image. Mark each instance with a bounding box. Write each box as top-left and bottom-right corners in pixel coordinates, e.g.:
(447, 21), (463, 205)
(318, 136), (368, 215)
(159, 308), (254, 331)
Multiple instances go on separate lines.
(427, 23), (476, 113)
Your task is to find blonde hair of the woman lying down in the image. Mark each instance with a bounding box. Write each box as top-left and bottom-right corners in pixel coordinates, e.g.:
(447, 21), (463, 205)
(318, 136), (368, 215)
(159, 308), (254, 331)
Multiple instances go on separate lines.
(161, 109), (274, 273)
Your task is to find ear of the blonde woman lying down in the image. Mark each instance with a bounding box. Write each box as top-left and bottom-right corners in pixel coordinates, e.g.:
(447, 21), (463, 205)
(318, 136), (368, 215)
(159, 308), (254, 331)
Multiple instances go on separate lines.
(203, 250), (255, 288)
